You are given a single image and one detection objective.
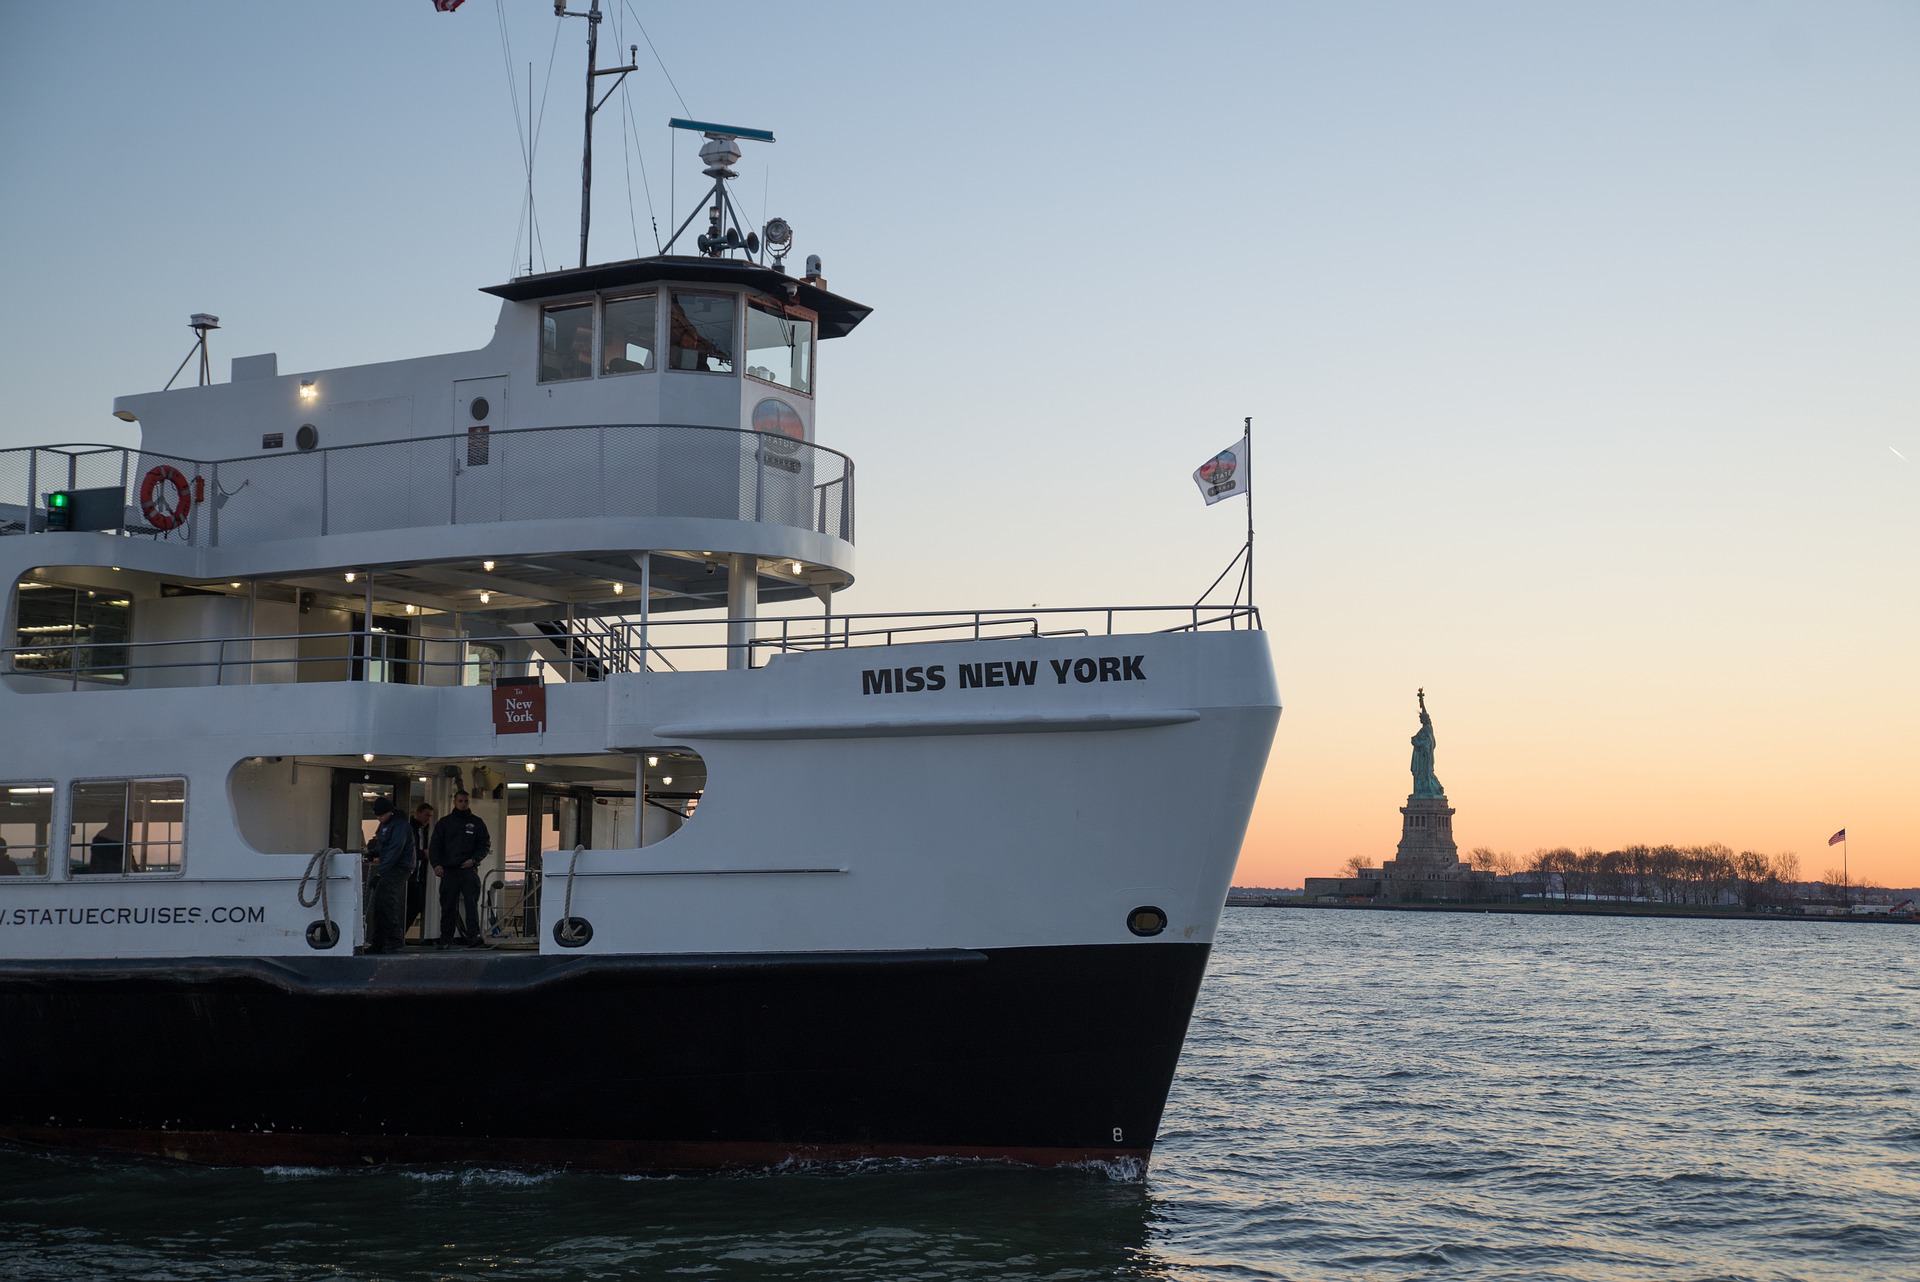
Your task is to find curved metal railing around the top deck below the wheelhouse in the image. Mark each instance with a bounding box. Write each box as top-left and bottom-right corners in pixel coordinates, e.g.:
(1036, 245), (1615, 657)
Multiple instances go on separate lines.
(0, 424), (854, 547)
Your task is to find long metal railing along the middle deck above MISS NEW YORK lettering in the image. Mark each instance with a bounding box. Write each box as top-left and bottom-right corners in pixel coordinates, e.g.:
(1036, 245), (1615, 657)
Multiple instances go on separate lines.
(0, 605), (1260, 689)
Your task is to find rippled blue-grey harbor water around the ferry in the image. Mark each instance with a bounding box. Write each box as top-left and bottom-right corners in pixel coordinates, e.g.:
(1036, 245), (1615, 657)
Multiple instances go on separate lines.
(0, 910), (1920, 1282)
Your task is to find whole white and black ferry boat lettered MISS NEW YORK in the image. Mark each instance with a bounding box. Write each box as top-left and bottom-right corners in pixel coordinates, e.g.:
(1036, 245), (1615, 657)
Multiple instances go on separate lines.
(0, 4), (1279, 1171)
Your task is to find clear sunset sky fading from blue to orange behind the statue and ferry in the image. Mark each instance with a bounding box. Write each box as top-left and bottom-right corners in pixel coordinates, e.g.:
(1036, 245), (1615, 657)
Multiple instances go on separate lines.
(0, 0), (1920, 885)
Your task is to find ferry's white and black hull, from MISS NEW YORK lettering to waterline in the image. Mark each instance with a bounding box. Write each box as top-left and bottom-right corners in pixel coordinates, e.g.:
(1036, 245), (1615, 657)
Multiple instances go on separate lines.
(0, 631), (1279, 1169)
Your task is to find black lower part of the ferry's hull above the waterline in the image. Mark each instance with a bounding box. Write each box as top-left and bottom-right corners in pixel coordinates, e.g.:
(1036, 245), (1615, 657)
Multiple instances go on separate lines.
(0, 942), (1208, 1171)
